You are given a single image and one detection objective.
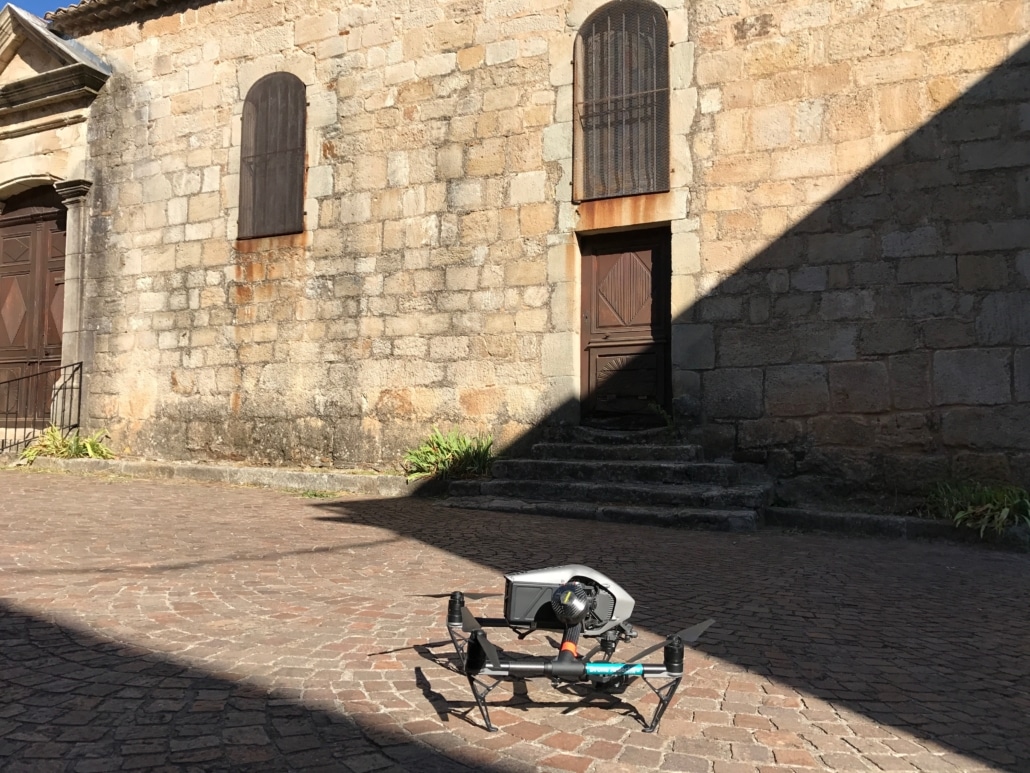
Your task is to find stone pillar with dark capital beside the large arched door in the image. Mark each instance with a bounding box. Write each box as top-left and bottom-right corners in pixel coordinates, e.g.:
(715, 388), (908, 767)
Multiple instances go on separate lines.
(54, 179), (93, 365)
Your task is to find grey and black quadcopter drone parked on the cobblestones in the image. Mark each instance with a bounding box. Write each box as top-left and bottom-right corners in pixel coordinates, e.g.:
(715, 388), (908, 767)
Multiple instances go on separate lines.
(447, 564), (715, 733)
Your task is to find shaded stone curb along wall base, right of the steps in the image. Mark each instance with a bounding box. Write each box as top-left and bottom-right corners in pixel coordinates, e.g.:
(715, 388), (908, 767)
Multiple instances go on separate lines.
(764, 507), (1030, 552)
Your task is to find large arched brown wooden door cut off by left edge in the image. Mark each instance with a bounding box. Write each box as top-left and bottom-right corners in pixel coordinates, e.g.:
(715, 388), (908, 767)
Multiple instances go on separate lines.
(0, 188), (65, 419)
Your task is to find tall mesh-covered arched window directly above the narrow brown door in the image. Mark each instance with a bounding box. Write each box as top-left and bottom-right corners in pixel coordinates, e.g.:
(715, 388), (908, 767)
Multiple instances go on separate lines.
(575, 0), (668, 201)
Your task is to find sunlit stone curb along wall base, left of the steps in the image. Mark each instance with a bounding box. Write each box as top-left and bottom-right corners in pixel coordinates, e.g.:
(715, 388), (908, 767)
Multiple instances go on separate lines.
(11, 457), (414, 499)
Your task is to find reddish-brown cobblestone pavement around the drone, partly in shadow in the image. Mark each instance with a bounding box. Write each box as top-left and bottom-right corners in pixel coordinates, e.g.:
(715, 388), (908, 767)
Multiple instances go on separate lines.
(0, 471), (1030, 773)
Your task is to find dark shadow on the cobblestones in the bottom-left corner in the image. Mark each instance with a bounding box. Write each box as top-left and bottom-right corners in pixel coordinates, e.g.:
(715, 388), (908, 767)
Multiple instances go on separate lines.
(0, 603), (489, 773)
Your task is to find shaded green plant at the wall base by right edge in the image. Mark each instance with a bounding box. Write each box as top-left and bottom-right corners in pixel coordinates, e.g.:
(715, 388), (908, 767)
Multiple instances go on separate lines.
(926, 480), (1030, 537)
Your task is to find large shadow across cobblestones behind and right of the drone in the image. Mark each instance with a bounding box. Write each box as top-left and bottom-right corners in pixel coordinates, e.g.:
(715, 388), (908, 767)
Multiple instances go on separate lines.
(314, 500), (1030, 771)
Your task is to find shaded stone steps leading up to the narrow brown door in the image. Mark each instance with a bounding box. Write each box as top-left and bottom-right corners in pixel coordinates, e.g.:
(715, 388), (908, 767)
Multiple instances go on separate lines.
(443, 428), (773, 532)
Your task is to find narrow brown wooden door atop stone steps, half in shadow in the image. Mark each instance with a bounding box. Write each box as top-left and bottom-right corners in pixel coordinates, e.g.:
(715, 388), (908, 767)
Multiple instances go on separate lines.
(581, 230), (672, 429)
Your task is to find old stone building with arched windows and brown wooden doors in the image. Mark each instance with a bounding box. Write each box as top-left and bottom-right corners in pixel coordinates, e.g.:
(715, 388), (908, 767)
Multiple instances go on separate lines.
(0, 0), (1030, 490)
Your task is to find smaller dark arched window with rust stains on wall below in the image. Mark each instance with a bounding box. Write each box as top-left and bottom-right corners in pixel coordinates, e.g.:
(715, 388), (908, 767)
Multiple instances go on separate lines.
(238, 72), (307, 239)
